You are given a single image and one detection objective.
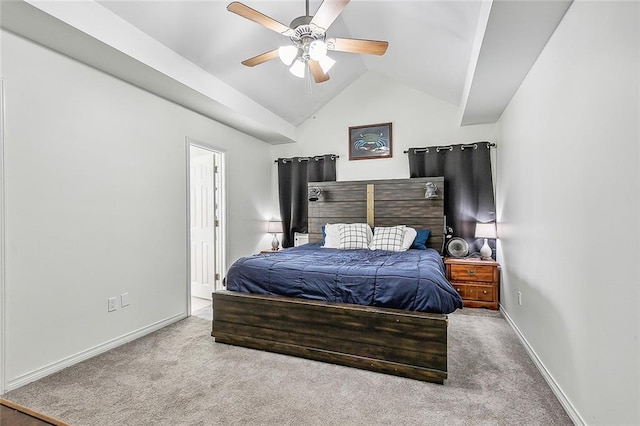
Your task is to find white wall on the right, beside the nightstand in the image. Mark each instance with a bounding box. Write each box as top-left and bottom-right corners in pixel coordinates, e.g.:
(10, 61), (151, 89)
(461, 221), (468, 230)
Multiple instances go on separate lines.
(497, 1), (640, 425)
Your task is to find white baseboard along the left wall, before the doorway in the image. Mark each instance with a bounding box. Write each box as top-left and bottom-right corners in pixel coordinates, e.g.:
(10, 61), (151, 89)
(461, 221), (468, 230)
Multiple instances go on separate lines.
(5, 312), (187, 392)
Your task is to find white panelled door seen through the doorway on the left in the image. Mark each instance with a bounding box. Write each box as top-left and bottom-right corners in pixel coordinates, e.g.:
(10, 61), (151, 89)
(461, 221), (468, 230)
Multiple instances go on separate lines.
(190, 146), (217, 299)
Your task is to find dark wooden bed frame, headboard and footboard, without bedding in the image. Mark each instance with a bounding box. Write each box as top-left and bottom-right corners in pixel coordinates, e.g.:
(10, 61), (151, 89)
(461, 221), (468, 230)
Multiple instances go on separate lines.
(211, 177), (448, 384)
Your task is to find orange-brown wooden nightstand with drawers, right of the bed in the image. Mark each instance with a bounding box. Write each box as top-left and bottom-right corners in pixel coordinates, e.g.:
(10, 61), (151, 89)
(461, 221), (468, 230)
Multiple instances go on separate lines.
(444, 257), (500, 309)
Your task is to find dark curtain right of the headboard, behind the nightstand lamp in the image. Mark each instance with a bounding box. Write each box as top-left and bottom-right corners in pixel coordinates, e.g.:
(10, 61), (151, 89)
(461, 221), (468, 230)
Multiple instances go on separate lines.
(408, 142), (496, 252)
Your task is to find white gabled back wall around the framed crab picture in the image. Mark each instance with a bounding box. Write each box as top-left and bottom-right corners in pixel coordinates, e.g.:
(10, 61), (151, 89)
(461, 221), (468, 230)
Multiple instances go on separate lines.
(273, 72), (496, 181)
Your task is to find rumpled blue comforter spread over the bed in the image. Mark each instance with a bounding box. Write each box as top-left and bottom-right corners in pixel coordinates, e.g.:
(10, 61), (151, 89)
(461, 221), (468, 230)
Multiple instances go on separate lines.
(225, 244), (462, 314)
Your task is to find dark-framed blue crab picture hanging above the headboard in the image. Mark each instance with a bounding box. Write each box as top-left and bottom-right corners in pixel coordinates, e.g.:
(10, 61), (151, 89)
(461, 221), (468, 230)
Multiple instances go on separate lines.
(349, 123), (393, 160)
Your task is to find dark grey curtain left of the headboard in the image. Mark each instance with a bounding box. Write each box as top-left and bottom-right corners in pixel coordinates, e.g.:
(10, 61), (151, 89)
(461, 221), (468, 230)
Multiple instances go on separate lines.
(278, 154), (337, 247)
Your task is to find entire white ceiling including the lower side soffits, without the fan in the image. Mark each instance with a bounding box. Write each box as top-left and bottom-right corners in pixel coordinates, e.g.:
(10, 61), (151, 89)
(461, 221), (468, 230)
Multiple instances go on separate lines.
(1, 0), (571, 143)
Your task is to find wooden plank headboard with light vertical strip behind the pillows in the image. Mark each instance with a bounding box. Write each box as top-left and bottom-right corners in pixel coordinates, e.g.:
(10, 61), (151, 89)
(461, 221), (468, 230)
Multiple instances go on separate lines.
(308, 176), (444, 251)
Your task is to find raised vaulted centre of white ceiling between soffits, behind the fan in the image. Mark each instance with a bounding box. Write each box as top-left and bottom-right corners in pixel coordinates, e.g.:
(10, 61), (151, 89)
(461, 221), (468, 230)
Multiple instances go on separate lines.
(99, 0), (480, 126)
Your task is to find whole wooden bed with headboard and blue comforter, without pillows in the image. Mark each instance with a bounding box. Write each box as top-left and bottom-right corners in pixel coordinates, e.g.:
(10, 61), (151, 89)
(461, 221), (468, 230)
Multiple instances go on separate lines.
(211, 177), (462, 383)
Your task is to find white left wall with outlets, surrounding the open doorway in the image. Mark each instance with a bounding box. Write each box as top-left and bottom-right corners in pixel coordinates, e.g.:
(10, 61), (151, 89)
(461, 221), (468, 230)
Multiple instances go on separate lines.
(0, 31), (273, 388)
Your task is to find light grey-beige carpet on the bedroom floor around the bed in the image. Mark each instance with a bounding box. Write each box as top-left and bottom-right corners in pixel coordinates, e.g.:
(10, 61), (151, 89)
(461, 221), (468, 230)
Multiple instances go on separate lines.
(5, 309), (571, 426)
